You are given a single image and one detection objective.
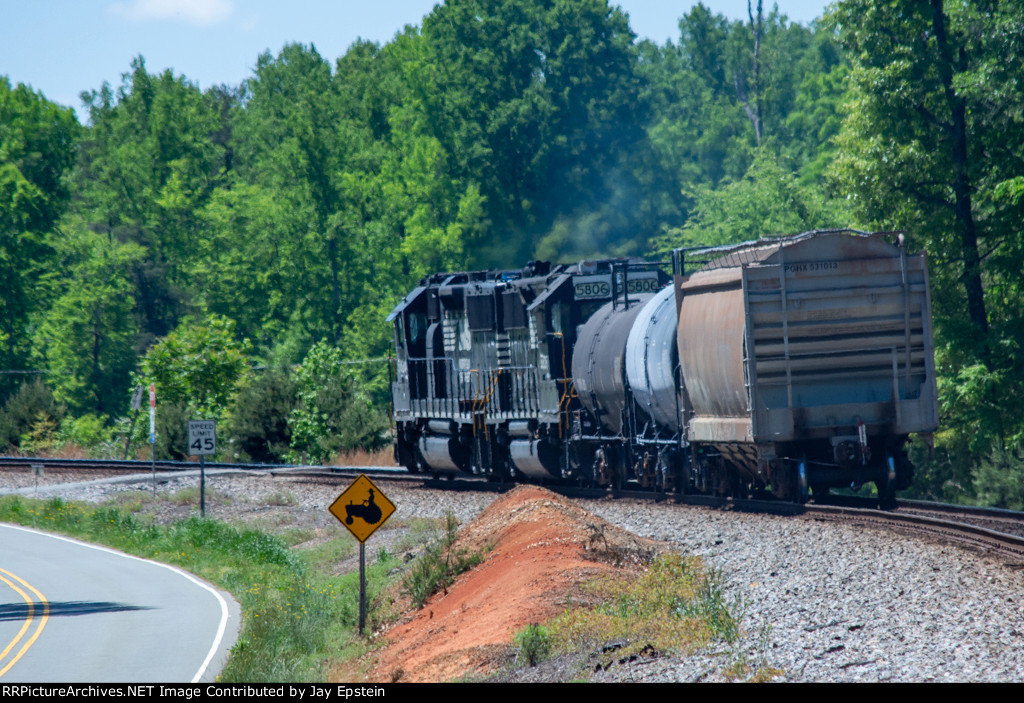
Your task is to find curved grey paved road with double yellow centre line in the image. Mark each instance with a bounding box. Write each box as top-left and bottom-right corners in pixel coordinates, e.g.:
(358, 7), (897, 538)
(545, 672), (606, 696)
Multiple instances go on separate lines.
(0, 524), (240, 684)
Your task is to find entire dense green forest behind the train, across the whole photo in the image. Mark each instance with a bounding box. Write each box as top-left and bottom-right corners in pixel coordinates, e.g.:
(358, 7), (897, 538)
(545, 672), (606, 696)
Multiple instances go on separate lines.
(0, 0), (1024, 504)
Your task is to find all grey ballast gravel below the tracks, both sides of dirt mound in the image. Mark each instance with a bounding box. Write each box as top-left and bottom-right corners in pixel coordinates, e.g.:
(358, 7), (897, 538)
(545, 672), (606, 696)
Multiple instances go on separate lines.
(0, 472), (1024, 683)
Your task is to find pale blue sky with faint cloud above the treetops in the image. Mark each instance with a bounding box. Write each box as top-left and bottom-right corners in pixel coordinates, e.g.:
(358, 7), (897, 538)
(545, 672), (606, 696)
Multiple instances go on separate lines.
(0, 0), (826, 119)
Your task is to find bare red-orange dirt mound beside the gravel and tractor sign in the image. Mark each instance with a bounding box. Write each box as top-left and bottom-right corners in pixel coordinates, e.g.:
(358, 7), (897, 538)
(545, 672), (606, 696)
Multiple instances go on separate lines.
(356, 486), (653, 682)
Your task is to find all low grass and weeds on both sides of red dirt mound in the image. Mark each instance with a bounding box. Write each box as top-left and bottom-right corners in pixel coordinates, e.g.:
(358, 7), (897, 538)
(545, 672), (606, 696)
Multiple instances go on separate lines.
(0, 492), (779, 683)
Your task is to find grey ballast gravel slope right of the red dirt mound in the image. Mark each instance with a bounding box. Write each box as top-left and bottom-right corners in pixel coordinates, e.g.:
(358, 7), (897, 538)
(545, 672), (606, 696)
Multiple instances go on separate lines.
(584, 501), (1024, 682)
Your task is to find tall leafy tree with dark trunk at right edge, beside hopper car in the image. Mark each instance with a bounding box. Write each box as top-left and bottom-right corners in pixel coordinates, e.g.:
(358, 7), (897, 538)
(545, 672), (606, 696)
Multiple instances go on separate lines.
(830, 0), (1024, 497)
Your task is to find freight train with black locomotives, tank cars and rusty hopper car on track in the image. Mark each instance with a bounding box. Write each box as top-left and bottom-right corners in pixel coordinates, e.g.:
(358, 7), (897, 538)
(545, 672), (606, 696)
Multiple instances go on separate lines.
(388, 230), (938, 504)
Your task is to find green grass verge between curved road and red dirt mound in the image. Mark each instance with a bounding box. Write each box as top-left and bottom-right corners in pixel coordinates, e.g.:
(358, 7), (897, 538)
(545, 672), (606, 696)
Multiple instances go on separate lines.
(0, 496), (399, 683)
